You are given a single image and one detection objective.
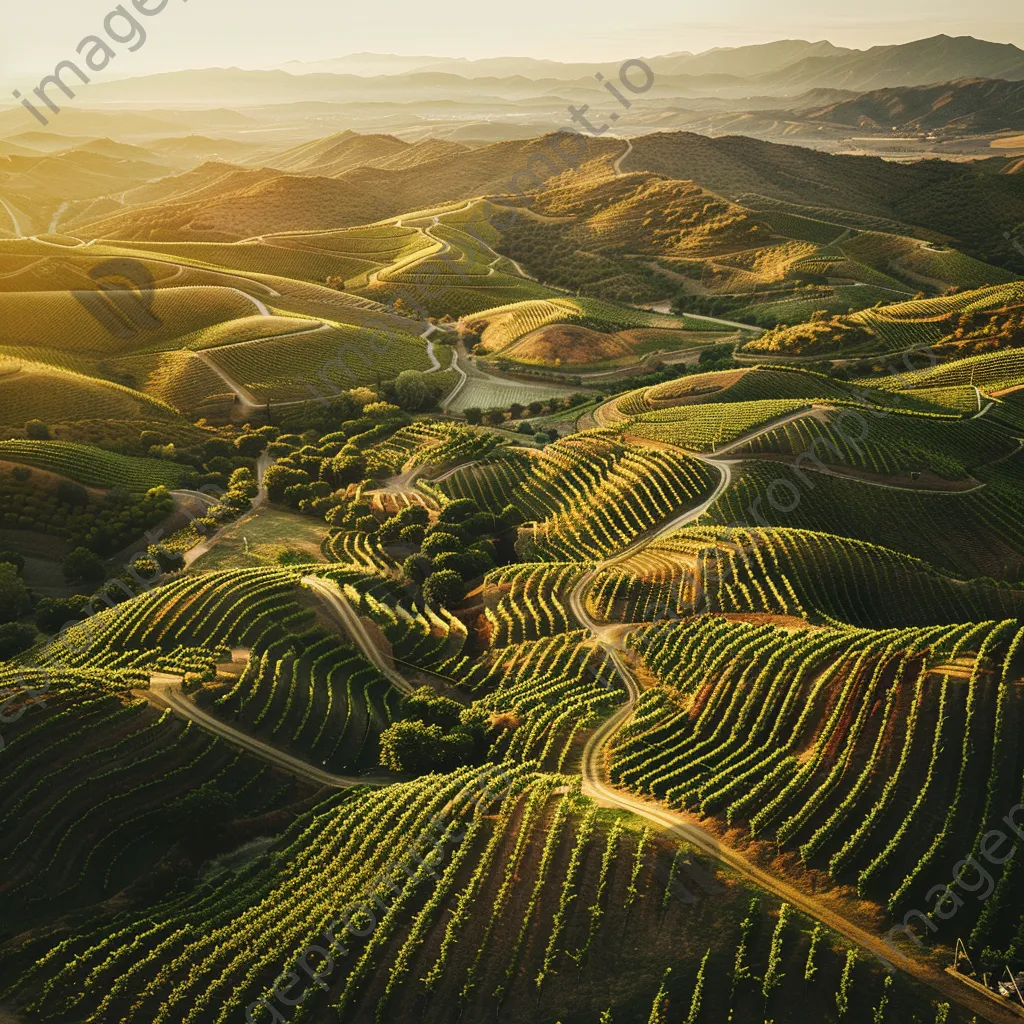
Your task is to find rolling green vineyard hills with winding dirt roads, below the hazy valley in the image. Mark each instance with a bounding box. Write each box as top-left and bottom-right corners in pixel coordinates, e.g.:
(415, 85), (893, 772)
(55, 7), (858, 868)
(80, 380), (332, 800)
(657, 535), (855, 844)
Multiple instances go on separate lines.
(0, 121), (1024, 1024)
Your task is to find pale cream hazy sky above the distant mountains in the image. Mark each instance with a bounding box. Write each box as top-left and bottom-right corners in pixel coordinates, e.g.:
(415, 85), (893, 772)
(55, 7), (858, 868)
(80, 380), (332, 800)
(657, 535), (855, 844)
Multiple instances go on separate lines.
(0, 0), (1024, 80)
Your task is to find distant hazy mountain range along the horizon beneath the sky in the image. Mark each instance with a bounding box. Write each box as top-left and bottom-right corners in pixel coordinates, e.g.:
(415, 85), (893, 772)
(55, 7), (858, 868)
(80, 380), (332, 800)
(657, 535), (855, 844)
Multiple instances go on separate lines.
(8, 35), (1024, 113)
